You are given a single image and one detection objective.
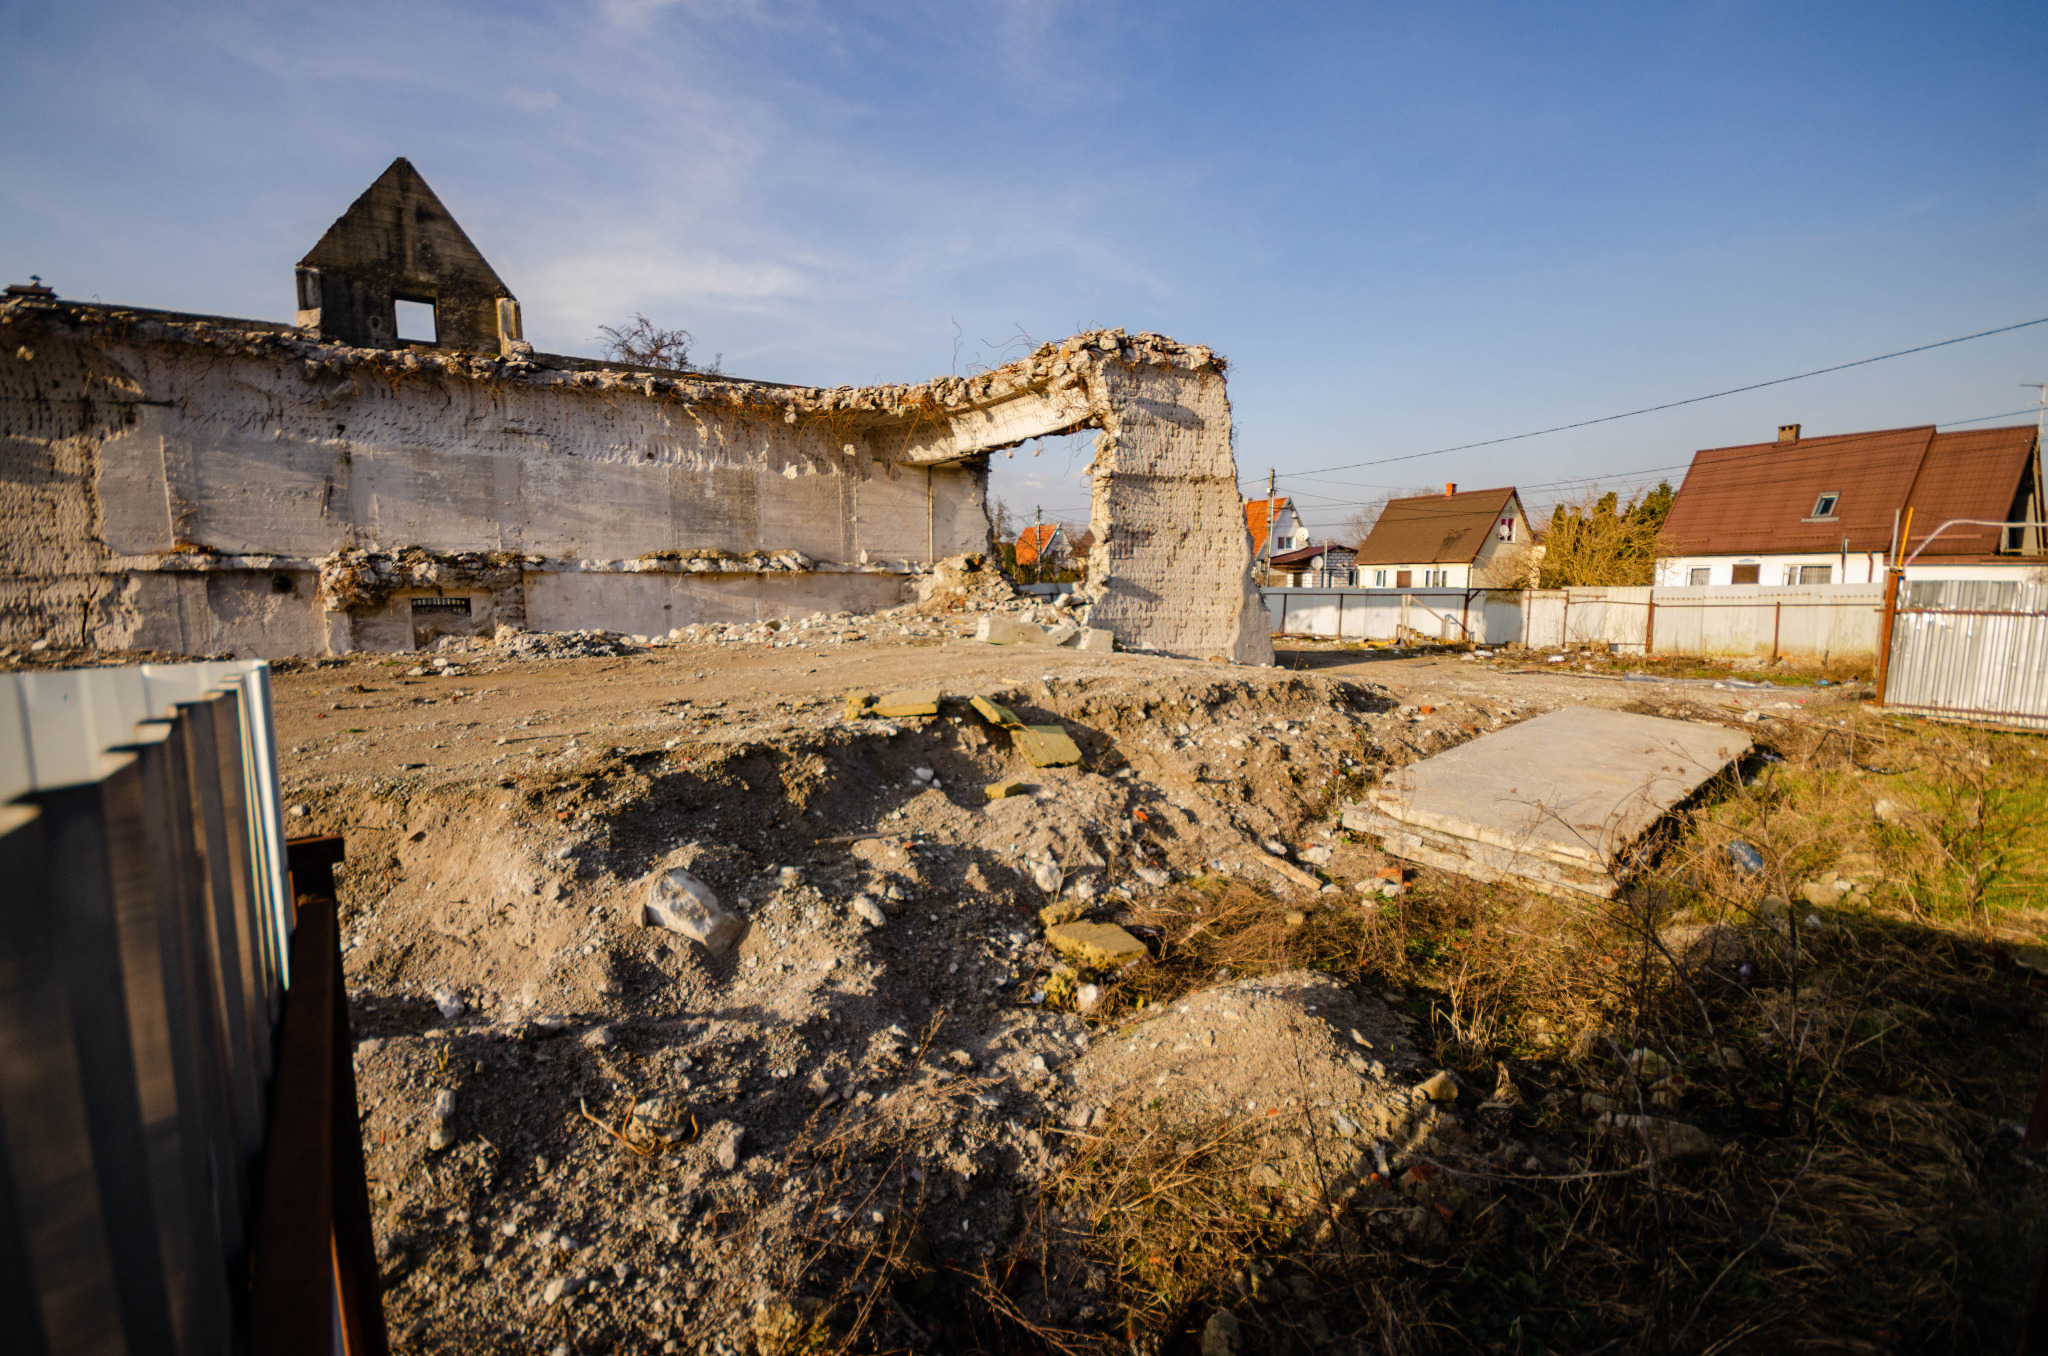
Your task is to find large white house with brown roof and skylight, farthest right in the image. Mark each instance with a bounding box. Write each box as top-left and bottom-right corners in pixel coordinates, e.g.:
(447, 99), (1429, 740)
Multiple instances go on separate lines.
(1657, 424), (2048, 586)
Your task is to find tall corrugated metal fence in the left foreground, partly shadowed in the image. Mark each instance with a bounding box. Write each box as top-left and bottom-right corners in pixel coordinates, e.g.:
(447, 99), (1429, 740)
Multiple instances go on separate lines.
(0, 662), (381, 1356)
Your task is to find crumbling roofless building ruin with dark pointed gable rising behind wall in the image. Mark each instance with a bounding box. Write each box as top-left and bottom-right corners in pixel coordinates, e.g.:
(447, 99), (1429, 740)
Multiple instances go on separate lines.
(0, 160), (1272, 662)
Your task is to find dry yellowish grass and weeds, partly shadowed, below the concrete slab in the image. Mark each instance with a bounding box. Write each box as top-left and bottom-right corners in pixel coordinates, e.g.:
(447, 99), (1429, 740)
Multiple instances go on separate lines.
(966, 705), (2048, 1354)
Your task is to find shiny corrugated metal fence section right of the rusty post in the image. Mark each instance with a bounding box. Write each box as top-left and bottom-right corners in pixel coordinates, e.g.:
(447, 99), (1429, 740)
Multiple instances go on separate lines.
(1878, 580), (2048, 729)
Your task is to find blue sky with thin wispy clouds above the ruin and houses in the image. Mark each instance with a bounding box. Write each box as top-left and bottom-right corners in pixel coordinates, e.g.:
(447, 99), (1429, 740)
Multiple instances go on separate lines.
(0, 0), (2048, 537)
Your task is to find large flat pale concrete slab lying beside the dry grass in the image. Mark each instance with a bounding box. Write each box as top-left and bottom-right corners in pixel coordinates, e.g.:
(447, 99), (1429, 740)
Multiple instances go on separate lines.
(1343, 707), (1749, 899)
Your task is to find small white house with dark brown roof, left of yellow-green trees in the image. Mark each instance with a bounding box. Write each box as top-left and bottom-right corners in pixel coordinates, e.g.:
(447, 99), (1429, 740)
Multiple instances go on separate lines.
(1352, 485), (1534, 588)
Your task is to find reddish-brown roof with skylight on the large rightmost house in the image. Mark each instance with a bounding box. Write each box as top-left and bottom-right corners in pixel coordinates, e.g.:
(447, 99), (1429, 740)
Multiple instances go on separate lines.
(1657, 424), (2034, 555)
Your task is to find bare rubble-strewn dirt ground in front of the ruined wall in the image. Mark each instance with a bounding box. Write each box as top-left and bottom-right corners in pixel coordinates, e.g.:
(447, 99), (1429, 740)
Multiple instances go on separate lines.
(256, 615), (2048, 1354)
